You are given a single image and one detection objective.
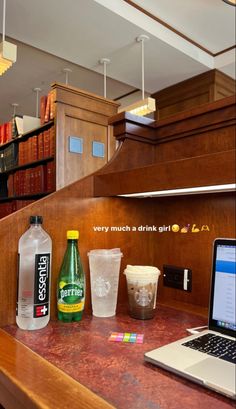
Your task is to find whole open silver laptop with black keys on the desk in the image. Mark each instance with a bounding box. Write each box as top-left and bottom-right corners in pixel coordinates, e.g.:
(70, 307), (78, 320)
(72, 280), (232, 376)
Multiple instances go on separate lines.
(144, 239), (236, 399)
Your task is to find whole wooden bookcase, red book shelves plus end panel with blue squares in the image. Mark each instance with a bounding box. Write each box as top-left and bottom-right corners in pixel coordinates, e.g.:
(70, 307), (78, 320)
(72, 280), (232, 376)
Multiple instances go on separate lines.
(0, 84), (119, 218)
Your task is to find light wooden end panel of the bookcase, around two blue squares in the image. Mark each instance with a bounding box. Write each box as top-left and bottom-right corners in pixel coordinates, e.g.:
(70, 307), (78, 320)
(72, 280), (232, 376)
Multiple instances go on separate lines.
(52, 84), (119, 190)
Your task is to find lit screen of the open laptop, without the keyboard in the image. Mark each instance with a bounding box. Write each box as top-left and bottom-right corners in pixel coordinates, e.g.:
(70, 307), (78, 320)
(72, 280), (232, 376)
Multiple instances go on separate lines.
(209, 239), (236, 336)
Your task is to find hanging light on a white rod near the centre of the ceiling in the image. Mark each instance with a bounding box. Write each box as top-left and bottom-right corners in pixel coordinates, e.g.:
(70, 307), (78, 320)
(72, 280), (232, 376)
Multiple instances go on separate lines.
(119, 34), (156, 116)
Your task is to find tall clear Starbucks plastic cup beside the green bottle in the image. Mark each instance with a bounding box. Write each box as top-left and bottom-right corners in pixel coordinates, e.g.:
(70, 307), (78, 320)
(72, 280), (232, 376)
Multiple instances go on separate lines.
(88, 248), (123, 317)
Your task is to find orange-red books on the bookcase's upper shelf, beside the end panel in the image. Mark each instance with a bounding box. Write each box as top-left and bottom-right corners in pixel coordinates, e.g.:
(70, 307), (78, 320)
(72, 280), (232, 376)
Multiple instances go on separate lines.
(18, 126), (55, 166)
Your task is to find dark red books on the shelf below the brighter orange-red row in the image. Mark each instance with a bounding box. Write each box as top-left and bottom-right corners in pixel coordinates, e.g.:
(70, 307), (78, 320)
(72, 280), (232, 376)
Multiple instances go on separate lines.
(7, 162), (55, 197)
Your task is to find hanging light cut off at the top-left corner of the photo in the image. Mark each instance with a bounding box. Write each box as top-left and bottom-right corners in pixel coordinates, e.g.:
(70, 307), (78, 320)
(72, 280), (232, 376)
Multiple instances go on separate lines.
(0, 0), (17, 75)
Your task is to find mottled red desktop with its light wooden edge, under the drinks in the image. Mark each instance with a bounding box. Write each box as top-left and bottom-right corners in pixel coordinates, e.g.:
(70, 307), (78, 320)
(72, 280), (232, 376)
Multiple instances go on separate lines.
(0, 306), (235, 409)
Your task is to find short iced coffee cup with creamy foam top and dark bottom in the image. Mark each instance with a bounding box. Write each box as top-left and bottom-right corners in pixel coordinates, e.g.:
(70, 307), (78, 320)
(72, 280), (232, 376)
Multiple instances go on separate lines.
(124, 265), (160, 320)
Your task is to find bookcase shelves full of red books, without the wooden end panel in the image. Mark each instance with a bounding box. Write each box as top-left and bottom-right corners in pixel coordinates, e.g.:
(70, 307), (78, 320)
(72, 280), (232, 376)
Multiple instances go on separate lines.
(0, 121), (56, 218)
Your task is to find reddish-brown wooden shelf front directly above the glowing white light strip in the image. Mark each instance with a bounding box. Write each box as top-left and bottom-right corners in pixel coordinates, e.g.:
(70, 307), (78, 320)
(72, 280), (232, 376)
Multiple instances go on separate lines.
(94, 149), (235, 197)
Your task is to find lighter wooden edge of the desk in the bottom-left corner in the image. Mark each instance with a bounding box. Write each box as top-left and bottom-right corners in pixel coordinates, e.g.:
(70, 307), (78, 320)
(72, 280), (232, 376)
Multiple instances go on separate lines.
(0, 329), (114, 409)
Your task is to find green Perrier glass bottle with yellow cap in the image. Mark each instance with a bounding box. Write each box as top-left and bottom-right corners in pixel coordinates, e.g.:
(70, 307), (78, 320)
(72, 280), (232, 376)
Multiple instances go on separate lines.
(57, 230), (85, 322)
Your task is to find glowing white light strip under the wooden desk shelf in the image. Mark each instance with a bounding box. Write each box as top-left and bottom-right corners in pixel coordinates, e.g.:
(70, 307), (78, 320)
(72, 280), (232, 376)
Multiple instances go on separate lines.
(118, 183), (236, 198)
